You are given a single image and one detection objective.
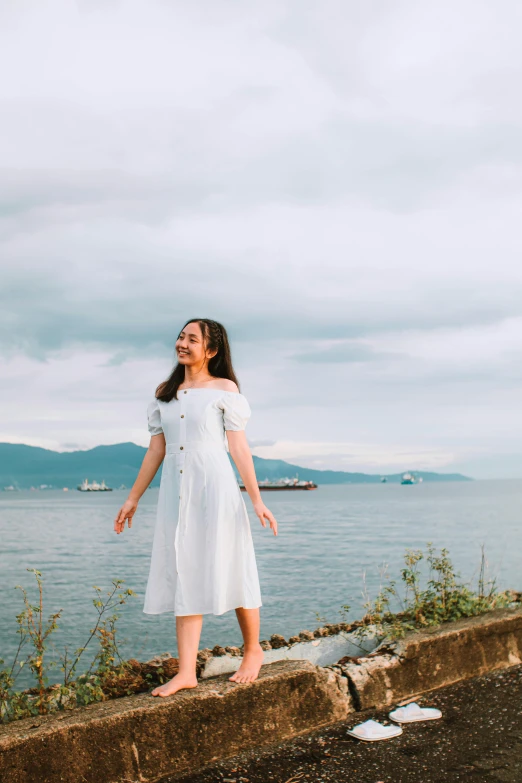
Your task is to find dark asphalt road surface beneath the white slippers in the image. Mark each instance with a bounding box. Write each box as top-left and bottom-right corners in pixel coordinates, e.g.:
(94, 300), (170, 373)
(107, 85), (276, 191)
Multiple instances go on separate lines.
(167, 666), (522, 783)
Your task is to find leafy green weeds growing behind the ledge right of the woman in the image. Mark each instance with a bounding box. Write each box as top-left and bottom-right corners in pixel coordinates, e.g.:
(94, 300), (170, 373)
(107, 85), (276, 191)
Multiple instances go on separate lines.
(355, 542), (513, 639)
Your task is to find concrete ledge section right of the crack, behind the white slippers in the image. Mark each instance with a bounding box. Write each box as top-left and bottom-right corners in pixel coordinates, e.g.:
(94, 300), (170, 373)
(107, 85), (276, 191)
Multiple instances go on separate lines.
(331, 608), (522, 710)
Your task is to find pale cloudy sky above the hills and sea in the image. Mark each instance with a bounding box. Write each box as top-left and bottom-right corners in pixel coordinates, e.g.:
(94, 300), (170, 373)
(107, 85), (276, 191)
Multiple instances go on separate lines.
(0, 0), (522, 478)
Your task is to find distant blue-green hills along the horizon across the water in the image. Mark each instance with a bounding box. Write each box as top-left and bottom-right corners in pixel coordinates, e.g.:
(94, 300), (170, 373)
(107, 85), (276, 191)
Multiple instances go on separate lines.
(0, 443), (473, 490)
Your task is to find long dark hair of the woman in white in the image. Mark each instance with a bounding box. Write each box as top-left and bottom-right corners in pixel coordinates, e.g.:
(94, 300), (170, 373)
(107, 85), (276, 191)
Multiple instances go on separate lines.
(152, 318), (239, 402)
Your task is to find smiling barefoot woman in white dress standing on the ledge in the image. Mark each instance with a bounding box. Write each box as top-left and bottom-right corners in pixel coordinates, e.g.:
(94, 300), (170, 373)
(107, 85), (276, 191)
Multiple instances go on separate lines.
(114, 318), (277, 696)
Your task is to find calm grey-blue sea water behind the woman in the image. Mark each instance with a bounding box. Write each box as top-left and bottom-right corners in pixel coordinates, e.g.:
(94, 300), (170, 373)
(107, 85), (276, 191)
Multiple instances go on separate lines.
(0, 480), (522, 687)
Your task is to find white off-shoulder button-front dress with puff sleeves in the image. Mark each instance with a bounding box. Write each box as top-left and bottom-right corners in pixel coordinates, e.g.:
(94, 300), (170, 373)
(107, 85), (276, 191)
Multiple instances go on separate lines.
(143, 387), (262, 615)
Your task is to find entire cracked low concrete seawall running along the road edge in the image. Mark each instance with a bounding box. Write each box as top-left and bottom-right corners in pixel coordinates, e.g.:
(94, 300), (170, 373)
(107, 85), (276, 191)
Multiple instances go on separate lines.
(0, 608), (522, 783)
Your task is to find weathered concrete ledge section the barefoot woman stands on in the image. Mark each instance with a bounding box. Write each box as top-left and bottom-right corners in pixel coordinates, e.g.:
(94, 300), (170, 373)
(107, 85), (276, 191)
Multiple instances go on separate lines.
(0, 661), (353, 783)
